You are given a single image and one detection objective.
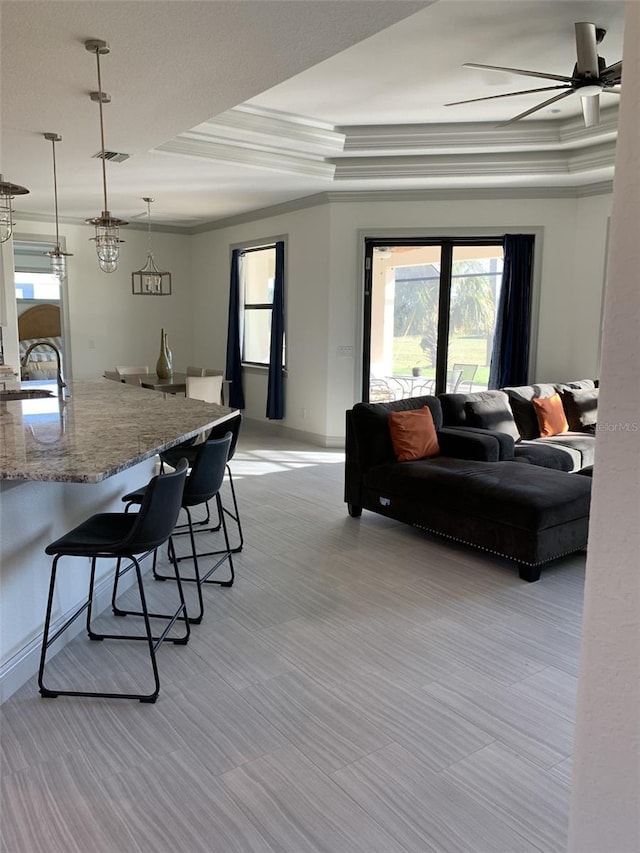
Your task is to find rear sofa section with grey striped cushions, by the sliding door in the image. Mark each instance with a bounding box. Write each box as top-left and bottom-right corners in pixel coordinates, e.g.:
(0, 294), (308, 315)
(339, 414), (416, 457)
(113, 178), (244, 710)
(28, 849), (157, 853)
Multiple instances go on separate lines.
(439, 379), (598, 471)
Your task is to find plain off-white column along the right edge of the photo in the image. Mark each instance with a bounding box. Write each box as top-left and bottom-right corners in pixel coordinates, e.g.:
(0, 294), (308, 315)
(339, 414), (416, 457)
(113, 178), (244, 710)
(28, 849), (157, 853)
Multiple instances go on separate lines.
(568, 0), (640, 853)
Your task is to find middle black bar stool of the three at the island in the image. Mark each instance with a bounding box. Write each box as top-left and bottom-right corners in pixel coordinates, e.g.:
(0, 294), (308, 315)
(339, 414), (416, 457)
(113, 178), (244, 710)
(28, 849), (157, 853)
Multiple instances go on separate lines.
(121, 432), (235, 624)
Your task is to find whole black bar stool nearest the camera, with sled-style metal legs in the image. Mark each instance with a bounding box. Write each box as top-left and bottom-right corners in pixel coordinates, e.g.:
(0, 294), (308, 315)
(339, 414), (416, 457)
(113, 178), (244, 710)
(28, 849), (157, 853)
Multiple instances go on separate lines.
(38, 459), (190, 702)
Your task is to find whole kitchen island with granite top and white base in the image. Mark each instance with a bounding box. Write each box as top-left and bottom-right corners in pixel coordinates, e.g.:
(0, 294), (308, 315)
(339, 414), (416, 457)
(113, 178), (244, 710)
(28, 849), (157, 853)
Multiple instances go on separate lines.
(0, 379), (236, 701)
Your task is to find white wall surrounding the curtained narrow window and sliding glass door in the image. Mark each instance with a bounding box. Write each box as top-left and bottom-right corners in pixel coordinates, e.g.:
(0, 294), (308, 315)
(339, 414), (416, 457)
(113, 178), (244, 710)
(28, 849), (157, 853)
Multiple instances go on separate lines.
(193, 195), (611, 444)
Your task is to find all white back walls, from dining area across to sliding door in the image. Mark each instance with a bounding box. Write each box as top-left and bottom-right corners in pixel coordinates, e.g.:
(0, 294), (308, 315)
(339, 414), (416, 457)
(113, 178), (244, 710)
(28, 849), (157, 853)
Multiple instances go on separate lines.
(5, 187), (611, 444)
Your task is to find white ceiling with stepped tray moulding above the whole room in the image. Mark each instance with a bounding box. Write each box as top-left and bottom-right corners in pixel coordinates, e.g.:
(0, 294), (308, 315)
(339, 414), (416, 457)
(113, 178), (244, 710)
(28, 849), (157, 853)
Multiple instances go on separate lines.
(0, 0), (624, 228)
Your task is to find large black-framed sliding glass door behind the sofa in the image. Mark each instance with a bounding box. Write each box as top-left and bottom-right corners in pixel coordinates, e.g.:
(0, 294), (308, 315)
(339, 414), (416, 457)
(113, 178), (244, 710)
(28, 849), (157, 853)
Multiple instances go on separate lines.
(362, 239), (503, 402)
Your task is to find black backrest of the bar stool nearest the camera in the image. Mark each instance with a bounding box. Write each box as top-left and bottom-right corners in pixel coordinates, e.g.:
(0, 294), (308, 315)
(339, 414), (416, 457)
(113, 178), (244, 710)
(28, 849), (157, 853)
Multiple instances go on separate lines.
(114, 459), (189, 554)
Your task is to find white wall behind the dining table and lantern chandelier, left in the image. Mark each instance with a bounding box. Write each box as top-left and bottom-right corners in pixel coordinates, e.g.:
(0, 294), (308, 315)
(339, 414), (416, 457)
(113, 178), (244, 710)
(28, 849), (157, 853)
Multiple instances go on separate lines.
(9, 220), (193, 379)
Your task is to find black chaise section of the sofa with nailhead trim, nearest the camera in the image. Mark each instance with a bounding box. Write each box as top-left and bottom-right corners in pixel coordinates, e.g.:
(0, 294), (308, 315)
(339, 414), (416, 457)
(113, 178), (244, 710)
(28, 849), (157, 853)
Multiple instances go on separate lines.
(345, 396), (591, 581)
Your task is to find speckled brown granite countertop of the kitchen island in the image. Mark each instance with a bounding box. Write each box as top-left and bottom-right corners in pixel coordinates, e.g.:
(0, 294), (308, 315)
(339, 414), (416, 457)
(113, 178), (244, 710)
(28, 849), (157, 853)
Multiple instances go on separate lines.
(0, 379), (236, 483)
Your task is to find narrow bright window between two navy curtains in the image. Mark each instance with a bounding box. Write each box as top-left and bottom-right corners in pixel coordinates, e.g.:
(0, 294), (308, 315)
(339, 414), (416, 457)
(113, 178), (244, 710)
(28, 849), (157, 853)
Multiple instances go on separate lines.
(240, 245), (284, 367)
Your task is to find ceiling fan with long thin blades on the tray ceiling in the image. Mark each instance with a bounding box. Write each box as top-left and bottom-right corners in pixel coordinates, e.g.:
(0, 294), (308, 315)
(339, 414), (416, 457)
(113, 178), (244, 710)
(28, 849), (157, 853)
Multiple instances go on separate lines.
(445, 21), (622, 127)
